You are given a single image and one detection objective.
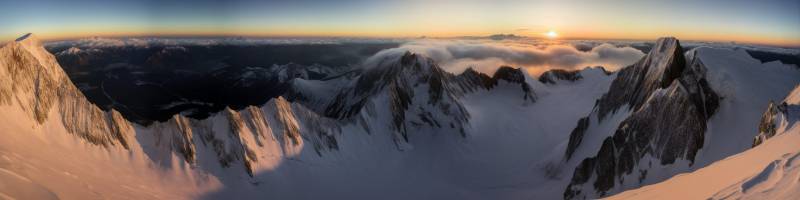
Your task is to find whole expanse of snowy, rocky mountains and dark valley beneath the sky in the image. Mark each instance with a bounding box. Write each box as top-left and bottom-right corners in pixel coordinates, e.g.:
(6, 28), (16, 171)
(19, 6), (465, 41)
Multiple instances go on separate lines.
(0, 35), (800, 199)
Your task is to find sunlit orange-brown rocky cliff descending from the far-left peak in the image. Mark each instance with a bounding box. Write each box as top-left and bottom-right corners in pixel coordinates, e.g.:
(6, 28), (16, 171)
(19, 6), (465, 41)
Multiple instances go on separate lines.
(0, 34), (132, 148)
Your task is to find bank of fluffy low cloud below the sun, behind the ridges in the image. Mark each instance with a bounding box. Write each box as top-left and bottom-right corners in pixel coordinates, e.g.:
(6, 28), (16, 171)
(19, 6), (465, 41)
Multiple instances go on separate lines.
(366, 40), (644, 75)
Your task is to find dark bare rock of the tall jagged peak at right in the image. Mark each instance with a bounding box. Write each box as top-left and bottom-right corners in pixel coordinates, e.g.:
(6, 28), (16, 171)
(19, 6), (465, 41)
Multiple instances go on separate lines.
(564, 38), (719, 199)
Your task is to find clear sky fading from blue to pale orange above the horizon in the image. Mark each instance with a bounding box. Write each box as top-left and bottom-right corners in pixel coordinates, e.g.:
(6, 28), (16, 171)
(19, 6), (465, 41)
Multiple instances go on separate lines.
(0, 0), (800, 46)
